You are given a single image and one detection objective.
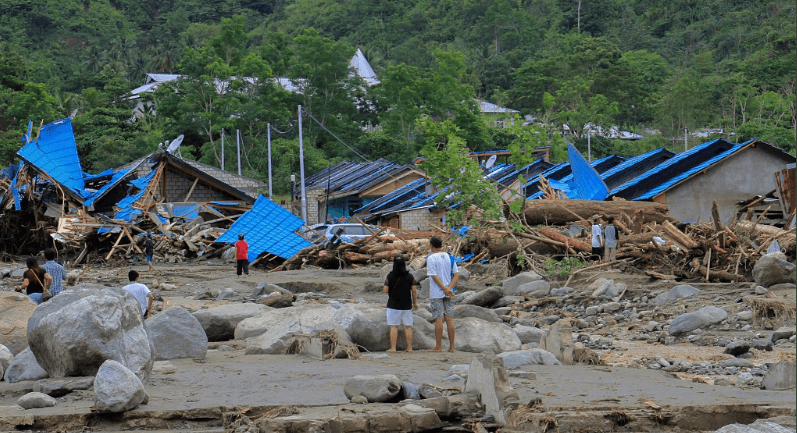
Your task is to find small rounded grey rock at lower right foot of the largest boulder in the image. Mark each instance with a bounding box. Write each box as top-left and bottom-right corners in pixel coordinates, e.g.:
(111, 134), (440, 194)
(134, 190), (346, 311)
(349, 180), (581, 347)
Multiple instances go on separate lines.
(94, 360), (149, 413)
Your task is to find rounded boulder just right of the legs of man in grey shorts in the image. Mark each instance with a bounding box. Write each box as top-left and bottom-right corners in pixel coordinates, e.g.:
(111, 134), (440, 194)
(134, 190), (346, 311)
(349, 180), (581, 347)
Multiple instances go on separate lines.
(454, 317), (521, 353)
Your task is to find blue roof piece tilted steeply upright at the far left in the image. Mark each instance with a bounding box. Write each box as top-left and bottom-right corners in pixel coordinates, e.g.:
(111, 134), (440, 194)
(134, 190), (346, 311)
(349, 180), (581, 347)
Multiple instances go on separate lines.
(17, 118), (87, 199)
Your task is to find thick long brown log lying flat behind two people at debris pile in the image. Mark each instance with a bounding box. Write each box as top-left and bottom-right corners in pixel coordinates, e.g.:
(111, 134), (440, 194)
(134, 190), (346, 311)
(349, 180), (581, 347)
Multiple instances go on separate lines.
(523, 200), (674, 225)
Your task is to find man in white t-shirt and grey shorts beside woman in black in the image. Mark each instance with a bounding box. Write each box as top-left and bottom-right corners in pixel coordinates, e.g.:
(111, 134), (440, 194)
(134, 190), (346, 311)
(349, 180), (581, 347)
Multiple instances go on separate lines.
(426, 236), (459, 352)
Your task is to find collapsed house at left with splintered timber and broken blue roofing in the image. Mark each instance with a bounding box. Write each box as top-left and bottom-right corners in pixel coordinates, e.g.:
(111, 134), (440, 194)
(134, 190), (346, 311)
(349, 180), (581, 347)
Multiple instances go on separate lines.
(2, 119), (309, 265)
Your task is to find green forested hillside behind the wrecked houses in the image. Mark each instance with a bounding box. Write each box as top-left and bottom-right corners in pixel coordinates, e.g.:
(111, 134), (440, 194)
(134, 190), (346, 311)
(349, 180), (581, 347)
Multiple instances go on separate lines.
(0, 0), (797, 191)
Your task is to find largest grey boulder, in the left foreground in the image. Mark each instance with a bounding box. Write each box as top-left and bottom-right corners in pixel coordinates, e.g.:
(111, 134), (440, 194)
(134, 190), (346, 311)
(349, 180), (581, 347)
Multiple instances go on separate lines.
(28, 287), (154, 381)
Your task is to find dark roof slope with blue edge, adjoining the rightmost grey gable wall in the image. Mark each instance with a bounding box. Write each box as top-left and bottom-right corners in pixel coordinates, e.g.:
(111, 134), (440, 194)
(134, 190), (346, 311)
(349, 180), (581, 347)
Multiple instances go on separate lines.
(609, 138), (737, 200)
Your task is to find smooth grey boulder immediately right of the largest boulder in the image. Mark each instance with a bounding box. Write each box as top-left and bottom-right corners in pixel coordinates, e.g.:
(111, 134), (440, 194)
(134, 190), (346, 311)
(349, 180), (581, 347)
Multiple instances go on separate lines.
(146, 307), (208, 361)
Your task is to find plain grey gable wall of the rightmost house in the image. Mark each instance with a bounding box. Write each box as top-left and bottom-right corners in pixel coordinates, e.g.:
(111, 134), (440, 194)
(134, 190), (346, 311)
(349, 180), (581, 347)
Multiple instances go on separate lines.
(656, 147), (787, 222)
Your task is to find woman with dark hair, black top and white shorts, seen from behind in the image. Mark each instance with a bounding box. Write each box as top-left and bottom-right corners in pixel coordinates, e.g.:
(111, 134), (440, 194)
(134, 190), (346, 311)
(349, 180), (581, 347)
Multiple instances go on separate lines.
(382, 254), (418, 353)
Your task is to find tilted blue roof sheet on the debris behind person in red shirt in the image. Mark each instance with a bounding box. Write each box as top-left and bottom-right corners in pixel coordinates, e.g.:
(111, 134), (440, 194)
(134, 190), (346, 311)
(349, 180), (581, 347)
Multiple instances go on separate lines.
(216, 195), (312, 262)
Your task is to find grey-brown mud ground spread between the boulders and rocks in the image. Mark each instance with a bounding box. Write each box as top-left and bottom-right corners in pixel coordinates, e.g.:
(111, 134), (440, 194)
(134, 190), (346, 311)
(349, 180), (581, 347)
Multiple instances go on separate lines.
(0, 261), (795, 431)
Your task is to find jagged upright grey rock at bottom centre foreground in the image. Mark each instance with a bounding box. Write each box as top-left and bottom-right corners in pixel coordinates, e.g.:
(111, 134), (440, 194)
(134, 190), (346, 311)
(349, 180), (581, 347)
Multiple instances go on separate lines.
(465, 355), (520, 425)
